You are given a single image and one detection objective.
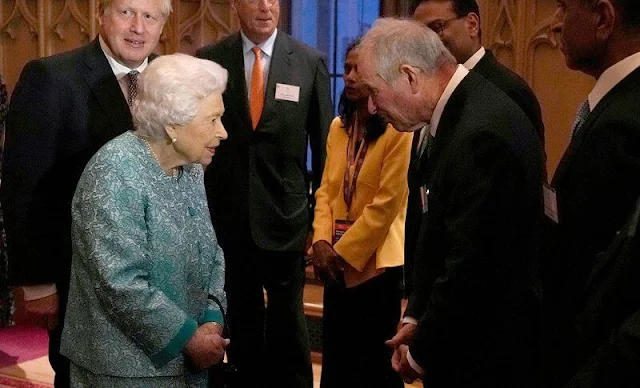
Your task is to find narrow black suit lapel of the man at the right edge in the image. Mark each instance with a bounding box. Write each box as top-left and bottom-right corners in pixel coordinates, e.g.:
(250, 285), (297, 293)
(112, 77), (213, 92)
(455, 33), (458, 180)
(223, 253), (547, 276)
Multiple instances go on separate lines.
(551, 68), (640, 187)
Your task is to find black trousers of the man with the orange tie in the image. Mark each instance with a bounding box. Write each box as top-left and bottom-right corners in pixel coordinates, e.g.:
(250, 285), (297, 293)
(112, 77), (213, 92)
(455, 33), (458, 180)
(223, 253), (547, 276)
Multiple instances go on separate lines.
(224, 243), (313, 388)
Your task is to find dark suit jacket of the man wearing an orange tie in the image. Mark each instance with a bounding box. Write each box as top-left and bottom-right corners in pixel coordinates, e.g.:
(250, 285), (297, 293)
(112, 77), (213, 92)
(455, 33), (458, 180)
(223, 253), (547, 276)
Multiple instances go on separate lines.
(196, 32), (333, 251)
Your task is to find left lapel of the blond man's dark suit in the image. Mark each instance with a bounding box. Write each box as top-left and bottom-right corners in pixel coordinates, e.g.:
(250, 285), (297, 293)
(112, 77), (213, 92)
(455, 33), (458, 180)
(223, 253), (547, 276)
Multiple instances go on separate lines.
(84, 38), (131, 133)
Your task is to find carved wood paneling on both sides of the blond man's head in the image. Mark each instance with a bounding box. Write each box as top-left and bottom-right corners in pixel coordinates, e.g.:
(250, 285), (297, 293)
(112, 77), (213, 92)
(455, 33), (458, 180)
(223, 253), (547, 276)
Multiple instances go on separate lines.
(0, 0), (238, 91)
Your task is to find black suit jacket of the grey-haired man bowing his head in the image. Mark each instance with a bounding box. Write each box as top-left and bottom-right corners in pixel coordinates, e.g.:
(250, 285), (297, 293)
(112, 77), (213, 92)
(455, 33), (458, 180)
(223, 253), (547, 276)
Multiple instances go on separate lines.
(406, 72), (543, 388)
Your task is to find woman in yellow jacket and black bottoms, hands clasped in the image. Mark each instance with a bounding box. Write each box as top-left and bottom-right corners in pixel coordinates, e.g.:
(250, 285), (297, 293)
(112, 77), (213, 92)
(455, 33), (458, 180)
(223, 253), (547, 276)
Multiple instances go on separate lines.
(309, 42), (412, 388)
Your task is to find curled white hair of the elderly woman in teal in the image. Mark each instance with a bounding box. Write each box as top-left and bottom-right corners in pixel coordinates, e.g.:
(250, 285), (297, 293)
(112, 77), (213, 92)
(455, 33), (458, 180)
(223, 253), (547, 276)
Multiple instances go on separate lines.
(133, 54), (228, 140)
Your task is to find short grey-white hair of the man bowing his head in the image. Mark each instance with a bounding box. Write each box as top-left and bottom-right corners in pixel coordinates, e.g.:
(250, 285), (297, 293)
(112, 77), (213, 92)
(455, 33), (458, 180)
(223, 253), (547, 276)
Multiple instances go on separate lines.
(360, 18), (456, 83)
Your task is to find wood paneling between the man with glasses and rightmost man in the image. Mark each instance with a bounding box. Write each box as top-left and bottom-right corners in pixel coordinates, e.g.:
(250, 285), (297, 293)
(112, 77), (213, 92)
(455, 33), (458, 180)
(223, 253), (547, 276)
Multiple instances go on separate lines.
(479, 0), (594, 174)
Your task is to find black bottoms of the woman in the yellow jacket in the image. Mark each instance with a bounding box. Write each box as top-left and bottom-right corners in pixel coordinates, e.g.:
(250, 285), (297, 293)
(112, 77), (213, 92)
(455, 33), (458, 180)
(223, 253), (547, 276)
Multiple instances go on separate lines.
(320, 268), (404, 388)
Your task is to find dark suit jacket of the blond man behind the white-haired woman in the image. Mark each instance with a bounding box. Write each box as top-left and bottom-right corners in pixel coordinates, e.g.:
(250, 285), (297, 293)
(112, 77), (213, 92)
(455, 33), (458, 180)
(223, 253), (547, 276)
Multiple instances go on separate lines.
(2, 38), (132, 300)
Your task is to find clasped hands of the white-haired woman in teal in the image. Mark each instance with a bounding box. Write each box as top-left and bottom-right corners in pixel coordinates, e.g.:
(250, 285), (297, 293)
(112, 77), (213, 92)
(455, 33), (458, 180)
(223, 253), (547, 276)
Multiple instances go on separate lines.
(184, 324), (231, 370)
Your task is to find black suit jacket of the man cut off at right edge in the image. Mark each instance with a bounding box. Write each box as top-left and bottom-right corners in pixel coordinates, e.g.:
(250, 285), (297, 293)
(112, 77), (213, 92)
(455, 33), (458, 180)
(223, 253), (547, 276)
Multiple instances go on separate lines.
(542, 69), (640, 379)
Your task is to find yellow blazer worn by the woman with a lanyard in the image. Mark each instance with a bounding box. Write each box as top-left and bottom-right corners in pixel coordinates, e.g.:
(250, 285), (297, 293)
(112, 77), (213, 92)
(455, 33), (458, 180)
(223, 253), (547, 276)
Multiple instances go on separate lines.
(313, 117), (412, 285)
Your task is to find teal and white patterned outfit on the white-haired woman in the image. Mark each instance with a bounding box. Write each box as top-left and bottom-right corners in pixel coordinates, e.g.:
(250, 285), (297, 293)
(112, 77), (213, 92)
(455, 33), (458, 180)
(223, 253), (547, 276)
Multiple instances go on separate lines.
(61, 132), (226, 388)
